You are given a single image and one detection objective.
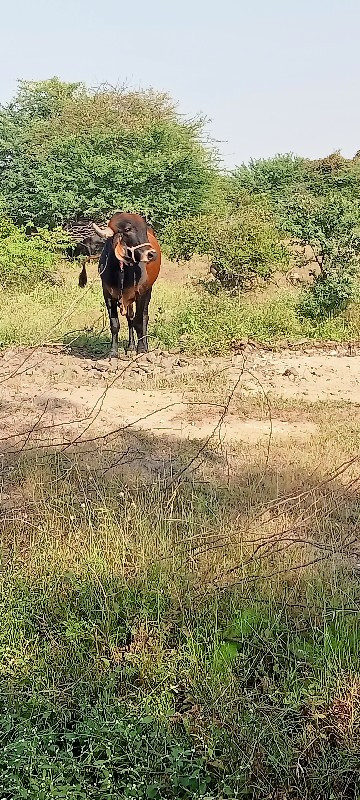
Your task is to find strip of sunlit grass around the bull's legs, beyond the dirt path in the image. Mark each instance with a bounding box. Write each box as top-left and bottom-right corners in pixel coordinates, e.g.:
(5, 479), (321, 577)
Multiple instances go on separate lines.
(0, 260), (360, 354)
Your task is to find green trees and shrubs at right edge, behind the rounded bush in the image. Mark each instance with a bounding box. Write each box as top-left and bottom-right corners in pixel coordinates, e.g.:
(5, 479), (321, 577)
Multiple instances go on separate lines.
(230, 152), (360, 319)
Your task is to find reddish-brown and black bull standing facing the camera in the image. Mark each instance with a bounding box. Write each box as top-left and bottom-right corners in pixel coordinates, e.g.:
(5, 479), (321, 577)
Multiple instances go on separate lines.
(79, 211), (161, 356)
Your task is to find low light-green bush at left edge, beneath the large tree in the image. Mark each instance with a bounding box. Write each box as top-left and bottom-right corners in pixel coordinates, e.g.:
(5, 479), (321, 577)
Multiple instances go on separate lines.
(0, 206), (69, 291)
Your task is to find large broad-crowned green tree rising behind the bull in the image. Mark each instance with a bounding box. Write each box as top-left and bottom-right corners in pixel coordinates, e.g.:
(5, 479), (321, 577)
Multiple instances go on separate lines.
(0, 79), (215, 228)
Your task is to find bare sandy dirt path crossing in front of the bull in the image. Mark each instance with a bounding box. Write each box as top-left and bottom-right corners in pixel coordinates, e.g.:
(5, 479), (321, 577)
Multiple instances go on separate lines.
(0, 340), (360, 449)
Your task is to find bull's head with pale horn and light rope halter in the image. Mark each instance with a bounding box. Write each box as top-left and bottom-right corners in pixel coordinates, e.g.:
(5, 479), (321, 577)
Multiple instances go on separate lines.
(93, 211), (158, 294)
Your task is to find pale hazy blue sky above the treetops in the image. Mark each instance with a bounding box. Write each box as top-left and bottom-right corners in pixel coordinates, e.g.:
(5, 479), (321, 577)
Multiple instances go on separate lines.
(0, 0), (360, 168)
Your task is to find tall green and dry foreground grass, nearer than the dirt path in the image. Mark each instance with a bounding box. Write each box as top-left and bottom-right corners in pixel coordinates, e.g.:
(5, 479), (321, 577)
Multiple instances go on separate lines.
(0, 400), (360, 800)
